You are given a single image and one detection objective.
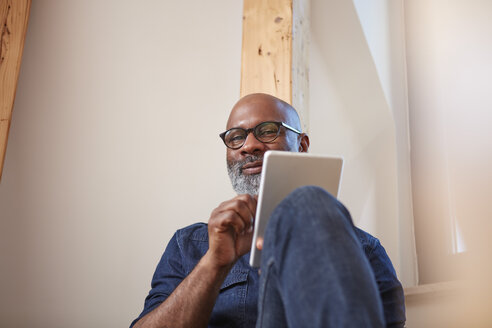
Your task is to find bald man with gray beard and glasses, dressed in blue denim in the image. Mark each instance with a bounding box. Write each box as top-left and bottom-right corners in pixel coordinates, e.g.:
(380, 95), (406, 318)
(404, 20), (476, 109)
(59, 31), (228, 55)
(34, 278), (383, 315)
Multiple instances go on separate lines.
(132, 94), (405, 327)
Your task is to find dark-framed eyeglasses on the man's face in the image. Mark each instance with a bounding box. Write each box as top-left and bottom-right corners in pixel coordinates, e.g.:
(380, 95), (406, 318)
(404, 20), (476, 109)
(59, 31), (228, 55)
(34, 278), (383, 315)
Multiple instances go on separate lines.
(219, 122), (301, 149)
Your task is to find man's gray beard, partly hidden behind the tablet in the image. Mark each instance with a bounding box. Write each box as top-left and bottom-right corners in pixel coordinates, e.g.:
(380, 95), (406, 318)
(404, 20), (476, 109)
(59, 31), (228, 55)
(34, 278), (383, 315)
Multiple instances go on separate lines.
(227, 155), (263, 195)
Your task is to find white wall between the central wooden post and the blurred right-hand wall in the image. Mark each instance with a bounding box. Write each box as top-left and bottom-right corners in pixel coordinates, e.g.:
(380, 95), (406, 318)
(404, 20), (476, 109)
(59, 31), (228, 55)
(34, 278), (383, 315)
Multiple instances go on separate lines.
(309, 0), (417, 286)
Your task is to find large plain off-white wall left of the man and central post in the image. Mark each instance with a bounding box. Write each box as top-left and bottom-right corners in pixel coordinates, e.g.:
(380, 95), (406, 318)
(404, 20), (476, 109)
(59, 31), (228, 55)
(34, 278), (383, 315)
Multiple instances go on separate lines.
(0, 0), (242, 327)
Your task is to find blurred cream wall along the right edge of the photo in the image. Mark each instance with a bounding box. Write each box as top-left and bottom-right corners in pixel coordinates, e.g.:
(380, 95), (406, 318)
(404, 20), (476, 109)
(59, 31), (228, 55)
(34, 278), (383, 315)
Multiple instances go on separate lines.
(405, 0), (492, 283)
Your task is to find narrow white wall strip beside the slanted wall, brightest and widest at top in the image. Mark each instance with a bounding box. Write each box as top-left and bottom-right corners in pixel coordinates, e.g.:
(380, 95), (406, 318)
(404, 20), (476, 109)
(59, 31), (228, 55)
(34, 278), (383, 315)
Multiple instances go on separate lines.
(354, 0), (418, 286)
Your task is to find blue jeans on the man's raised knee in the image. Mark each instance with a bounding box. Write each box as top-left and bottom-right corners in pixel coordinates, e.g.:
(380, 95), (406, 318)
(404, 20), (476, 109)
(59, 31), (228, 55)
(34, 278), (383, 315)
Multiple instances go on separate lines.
(256, 186), (385, 328)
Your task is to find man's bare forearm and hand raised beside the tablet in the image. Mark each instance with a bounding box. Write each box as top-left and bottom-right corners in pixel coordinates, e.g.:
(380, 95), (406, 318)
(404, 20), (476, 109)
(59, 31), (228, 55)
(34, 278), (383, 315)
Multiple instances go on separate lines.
(134, 195), (257, 328)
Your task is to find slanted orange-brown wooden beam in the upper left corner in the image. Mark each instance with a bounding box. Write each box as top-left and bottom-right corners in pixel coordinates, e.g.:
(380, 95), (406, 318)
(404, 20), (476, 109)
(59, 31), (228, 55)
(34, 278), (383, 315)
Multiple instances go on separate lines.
(0, 0), (31, 181)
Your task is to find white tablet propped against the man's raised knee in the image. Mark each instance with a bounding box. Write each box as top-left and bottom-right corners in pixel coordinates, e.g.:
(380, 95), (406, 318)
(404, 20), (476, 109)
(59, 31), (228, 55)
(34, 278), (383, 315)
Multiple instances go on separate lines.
(249, 151), (343, 267)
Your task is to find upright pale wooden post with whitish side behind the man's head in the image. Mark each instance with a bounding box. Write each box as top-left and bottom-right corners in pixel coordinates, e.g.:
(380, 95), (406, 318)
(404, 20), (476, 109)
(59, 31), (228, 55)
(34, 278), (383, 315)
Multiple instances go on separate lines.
(241, 0), (309, 131)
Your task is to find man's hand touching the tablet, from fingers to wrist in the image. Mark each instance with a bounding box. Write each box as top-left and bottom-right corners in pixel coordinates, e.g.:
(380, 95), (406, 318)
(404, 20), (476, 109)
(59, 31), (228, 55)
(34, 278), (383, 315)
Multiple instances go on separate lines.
(207, 194), (257, 267)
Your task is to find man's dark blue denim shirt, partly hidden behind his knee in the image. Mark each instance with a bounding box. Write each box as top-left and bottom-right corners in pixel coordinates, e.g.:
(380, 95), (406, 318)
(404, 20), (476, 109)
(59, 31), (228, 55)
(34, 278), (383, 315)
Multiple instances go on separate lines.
(131, 223), (405, 327)
